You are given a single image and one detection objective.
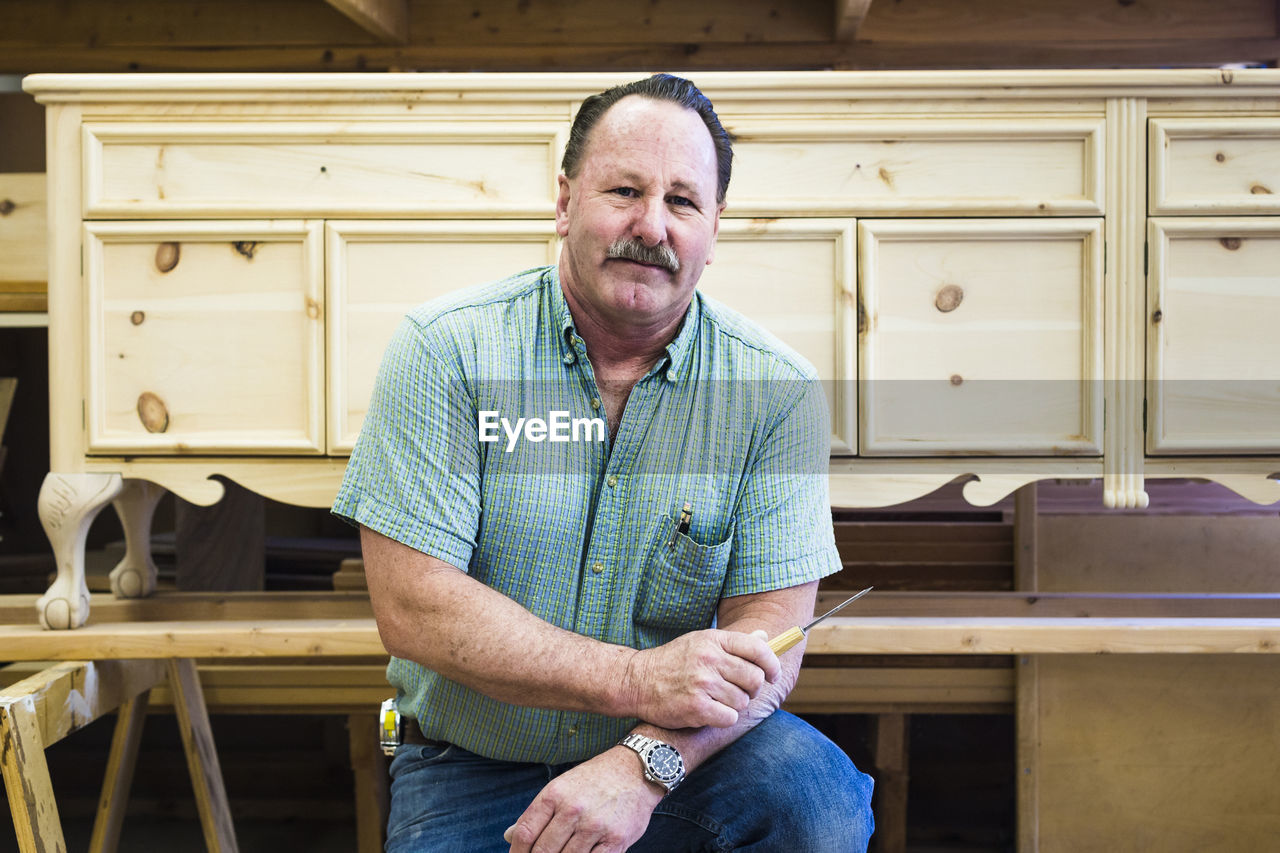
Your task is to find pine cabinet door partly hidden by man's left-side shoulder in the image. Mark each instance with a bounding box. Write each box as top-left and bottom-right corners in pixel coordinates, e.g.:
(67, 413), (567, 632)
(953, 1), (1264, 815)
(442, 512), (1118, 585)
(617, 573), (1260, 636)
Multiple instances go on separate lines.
(325, 219), (558, 455)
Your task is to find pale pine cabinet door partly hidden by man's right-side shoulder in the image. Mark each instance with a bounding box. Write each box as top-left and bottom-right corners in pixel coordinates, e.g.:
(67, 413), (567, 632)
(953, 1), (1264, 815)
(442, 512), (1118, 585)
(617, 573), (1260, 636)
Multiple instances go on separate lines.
(698, 219), (858, 453)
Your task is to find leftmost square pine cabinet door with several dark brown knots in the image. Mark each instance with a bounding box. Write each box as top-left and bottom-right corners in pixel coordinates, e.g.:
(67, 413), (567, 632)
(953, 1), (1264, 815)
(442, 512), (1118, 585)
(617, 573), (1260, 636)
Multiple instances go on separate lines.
(84, 222), (324, 453)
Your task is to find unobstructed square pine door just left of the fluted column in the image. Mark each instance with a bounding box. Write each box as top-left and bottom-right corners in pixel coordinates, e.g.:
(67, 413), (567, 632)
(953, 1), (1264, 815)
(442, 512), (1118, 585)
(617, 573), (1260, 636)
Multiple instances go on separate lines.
(858, 219), (1102, 456)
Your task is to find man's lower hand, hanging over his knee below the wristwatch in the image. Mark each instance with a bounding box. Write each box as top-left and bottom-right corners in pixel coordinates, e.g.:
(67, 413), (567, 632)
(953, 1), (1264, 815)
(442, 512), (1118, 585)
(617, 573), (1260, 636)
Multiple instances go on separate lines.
(503, 747), (663, 853)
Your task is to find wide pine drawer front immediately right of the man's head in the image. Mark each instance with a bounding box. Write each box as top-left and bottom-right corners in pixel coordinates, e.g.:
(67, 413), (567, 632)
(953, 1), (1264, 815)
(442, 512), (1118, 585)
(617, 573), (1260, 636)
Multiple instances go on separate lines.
(727, 119), (1103, 216)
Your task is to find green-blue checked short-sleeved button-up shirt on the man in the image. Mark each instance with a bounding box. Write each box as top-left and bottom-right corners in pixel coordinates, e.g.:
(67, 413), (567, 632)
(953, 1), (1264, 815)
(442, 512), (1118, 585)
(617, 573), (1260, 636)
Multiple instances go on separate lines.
(333, 266), (840, 763)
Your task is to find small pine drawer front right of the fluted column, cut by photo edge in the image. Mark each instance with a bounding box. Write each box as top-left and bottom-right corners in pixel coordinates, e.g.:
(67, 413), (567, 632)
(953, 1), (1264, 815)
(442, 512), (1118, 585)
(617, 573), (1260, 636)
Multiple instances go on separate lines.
(1149, 118), (1280, 214)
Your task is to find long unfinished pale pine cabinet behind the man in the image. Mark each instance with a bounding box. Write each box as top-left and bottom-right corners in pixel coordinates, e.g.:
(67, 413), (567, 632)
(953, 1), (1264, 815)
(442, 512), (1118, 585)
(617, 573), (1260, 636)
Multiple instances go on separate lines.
(24, 69), (1280, 625)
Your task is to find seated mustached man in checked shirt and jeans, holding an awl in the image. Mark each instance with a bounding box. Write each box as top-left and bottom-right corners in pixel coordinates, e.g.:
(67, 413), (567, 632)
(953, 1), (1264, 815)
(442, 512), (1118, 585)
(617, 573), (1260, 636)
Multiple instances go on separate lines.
(334, 76), (872, 853)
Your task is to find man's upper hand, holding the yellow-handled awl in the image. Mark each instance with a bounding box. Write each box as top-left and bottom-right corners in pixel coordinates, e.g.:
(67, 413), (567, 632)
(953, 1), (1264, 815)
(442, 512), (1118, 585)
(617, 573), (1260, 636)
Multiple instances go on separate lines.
(625, 629), (781, 729)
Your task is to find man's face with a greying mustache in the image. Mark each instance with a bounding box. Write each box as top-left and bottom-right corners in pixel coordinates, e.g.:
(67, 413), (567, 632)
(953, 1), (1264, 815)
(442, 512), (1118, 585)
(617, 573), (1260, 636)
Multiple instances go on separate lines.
(556, 95), (722, 327)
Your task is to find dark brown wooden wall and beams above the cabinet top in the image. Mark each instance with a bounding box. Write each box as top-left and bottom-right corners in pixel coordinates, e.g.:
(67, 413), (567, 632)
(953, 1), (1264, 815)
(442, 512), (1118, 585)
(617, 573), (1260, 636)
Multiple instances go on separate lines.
(0, 0), (1280, 74)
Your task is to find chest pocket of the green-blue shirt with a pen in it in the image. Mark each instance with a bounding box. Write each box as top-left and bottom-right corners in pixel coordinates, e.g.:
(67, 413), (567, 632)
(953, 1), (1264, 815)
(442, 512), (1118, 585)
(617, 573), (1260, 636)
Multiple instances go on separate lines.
(635, 514), (733, 635)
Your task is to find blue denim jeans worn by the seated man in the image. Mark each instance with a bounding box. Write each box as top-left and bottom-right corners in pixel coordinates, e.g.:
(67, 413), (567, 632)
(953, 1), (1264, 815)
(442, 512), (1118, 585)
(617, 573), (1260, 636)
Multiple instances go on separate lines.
(387, 711), (874, 853)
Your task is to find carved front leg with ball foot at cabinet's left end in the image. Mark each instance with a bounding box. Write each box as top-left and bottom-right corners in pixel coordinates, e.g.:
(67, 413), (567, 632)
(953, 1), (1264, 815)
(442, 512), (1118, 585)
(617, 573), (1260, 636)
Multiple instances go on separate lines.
(36, 473), (124, 629)
